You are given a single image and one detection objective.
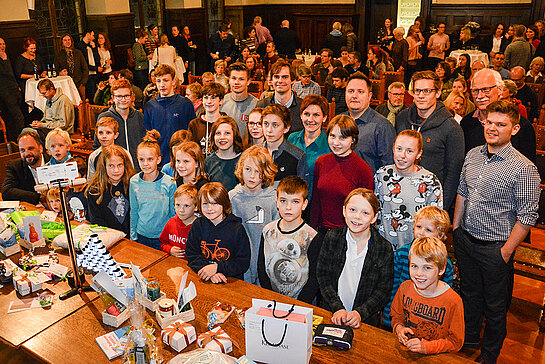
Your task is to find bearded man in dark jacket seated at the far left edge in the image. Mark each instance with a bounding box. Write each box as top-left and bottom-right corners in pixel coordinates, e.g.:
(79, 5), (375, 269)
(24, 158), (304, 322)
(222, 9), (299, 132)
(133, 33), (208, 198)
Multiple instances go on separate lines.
(2, 130), (49, 205)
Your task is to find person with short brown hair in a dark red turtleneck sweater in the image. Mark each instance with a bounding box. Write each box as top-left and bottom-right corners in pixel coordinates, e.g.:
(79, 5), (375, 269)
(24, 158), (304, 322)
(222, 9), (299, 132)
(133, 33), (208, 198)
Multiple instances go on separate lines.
(310, 115), (374, 232)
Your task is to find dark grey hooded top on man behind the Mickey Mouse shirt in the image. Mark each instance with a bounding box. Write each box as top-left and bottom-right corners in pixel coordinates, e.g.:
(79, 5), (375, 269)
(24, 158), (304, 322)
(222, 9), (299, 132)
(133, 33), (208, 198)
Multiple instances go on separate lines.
(395, 101), (465, 210)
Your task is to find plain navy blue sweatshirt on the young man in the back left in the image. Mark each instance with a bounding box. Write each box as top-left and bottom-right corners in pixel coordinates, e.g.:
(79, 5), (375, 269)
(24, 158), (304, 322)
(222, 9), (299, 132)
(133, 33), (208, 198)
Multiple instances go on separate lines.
(144, 93), (197, 166)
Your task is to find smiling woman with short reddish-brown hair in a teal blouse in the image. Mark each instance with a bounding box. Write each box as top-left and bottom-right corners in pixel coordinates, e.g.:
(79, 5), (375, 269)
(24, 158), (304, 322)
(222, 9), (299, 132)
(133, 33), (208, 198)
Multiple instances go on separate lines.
(288, 95), (331, 196)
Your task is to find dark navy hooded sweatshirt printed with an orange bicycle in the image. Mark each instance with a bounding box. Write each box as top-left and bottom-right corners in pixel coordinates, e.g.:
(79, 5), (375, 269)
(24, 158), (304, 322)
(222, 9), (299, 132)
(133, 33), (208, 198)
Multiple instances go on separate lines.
(185, 214), (250, 279)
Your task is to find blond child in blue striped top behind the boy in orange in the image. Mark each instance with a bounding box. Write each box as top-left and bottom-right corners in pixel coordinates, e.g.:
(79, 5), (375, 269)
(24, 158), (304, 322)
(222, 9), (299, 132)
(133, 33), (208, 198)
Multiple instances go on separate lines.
(382, 206), (453, 327)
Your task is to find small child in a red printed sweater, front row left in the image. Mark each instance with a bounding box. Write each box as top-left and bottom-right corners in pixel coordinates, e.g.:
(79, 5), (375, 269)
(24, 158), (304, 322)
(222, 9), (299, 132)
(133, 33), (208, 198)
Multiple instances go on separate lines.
(159, 183), (198, 259)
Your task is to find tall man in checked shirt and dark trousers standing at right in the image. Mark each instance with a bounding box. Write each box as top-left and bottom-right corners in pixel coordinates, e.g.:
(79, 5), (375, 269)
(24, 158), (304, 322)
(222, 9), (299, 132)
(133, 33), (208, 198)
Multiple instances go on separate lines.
(453, 100), (540, 363)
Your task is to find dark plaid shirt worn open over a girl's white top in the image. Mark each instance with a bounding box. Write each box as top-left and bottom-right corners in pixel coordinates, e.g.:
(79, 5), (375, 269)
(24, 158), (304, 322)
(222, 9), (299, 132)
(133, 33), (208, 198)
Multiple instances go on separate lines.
(316, 226), (394, 326)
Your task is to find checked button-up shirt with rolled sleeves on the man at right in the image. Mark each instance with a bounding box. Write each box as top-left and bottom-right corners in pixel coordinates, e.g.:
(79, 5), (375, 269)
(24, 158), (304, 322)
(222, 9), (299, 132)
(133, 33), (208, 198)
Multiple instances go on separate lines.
(458, 143), (540, 241)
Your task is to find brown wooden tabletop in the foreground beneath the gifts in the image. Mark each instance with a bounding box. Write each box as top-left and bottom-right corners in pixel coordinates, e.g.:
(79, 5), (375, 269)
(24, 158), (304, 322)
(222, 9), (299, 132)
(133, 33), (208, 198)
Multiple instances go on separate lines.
(23, 257), (469, 364)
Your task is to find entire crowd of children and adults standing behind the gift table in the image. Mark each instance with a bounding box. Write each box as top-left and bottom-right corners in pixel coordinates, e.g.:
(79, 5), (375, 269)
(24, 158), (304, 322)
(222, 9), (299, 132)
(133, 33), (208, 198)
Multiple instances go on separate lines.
(0, 17), (544, 363)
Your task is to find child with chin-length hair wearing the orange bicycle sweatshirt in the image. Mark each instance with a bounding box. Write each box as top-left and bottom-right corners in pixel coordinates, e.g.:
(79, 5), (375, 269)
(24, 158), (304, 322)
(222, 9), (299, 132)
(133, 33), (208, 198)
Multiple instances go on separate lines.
(186, 182), (250, 283)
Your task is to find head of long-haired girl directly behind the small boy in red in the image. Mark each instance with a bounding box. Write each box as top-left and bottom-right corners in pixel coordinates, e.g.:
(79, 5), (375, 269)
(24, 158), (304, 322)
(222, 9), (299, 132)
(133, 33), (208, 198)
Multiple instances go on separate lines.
(174, 141), (209, 190)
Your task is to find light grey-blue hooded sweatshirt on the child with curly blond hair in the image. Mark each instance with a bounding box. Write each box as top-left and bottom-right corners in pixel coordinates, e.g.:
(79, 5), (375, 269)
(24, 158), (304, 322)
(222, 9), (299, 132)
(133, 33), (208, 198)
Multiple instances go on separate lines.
(229, 184), (279, 284)
